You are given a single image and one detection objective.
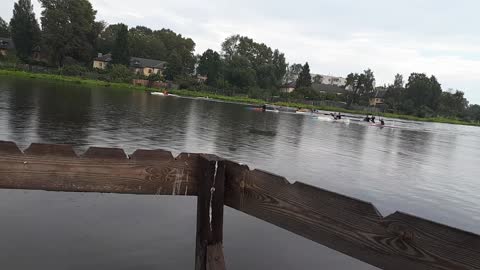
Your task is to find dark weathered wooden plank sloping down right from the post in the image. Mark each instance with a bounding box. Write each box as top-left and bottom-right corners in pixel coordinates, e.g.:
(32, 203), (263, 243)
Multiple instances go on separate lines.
(225, 162), (480, 270)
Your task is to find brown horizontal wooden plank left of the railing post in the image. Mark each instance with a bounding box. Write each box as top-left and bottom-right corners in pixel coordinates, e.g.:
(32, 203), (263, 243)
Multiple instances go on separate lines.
(0, 141), (198, 196)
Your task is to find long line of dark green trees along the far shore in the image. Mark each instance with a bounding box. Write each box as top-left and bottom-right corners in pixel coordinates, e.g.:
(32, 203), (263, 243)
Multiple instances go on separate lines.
(0, 0), (480, 121)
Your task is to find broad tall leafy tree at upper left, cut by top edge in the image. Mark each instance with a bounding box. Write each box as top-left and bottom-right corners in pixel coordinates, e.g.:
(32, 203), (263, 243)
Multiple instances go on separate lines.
(40, 0), (103, 66)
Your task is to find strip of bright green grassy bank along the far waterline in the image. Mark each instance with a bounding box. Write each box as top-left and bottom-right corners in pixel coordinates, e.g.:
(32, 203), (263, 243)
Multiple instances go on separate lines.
(0, 70), (480, 126)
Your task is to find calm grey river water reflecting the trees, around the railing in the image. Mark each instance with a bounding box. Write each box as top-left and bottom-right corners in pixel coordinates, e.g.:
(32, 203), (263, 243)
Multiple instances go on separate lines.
(0, 77), (480, 270)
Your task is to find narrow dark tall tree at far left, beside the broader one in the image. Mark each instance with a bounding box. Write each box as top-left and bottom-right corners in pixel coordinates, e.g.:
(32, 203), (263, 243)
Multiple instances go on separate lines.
(10, 0), (40, 61)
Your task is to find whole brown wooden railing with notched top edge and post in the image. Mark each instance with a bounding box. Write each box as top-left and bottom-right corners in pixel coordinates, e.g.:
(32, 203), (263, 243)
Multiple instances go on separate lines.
(0, 142), (480, 270)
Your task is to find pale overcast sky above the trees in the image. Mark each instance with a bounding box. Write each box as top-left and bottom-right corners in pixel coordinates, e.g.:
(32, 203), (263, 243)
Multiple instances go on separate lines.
(0, 0), (480, 103)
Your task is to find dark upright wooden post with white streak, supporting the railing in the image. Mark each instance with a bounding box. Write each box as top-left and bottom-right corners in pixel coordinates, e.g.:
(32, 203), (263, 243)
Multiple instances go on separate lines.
(195, 155), (225, 270)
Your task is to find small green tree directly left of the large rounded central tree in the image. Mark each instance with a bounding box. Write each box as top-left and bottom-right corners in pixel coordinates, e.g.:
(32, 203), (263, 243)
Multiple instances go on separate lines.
(197, 49), (222, 86)
